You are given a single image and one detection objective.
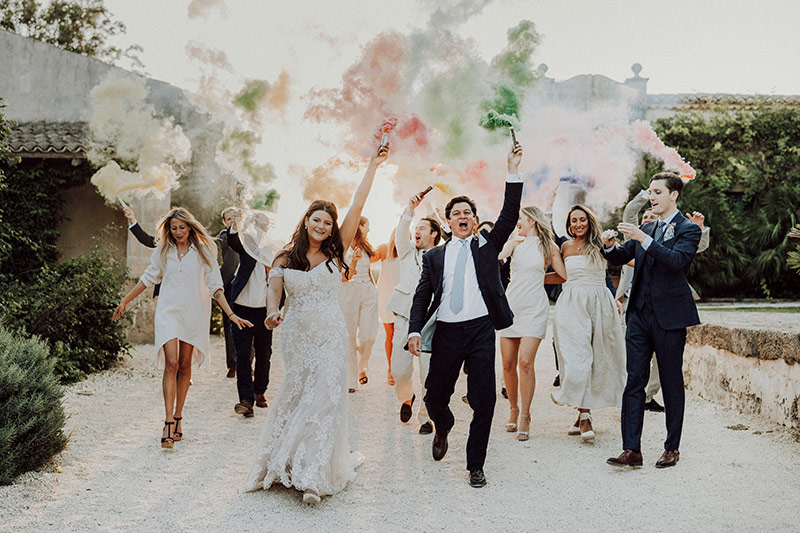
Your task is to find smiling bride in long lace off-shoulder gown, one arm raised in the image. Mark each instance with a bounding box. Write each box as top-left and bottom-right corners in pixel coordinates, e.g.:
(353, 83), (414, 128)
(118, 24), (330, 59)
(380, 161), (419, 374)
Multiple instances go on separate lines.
(245, 141), (389, 504)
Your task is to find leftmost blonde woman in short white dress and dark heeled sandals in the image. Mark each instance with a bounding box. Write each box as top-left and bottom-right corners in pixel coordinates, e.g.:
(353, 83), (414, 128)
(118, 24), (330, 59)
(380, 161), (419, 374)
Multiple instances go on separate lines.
(114, 207), (252, 448)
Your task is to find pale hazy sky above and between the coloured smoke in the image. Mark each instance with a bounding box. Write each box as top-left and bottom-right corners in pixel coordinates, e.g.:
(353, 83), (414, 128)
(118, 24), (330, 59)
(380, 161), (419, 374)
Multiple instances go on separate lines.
(106, 0), (800, 244)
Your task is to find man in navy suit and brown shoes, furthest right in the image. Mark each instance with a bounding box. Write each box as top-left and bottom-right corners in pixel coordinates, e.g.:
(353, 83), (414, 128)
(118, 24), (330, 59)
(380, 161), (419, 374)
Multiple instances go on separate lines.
(603, 172), (701, 468)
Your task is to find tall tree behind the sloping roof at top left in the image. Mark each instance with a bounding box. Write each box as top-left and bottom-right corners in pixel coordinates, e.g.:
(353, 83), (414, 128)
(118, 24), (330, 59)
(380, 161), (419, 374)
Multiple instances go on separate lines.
(0, 0), (143, 68)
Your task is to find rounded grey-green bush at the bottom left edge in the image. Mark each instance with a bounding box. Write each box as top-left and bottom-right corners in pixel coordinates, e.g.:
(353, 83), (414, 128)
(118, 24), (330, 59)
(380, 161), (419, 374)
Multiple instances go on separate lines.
(0, 328), (67, 485)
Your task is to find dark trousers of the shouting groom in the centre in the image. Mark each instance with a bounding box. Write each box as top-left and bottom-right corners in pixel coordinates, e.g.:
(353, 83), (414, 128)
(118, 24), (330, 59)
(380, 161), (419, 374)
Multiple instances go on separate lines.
(425, 316), (497, 471)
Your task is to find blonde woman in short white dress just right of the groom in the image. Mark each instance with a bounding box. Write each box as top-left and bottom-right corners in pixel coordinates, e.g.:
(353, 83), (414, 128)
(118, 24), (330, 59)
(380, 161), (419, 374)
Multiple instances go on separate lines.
(499, 206), (567, 441)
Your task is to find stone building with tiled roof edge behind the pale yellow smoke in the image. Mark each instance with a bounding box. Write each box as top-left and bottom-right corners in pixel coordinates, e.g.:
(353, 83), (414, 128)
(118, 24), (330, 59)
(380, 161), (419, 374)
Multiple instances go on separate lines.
(0, 30), (235, 342)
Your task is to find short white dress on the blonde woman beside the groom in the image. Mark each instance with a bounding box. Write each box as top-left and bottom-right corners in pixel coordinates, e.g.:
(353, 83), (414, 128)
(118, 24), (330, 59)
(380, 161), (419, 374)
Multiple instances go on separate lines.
(500, 235), (550, 339)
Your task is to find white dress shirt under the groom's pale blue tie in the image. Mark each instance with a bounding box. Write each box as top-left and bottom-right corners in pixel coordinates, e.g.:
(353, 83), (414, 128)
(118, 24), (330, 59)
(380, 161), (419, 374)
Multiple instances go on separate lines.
(436, 236), (489, 322)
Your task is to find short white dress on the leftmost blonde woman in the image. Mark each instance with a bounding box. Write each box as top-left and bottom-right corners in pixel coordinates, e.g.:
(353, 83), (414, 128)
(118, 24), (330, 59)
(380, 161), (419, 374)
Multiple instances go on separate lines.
(140, 244), (222, 369)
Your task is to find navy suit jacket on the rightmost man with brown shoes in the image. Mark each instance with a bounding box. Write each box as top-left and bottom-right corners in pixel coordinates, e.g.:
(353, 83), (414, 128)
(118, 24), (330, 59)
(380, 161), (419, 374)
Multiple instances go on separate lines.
(603, 211), (702, 330)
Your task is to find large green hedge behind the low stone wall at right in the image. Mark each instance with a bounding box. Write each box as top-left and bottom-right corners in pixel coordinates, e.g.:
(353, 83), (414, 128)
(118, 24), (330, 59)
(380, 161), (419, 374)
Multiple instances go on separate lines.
(630, 105), (800, 298)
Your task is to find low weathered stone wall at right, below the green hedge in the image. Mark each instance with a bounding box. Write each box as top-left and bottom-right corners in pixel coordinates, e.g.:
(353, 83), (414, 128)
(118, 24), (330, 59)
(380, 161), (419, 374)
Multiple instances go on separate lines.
(683, 320), (800, 429)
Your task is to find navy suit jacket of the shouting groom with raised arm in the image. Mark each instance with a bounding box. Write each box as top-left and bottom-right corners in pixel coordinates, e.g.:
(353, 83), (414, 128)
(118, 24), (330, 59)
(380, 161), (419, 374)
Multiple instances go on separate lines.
(408, 182), (522, 333)
